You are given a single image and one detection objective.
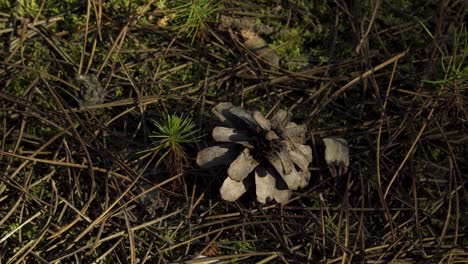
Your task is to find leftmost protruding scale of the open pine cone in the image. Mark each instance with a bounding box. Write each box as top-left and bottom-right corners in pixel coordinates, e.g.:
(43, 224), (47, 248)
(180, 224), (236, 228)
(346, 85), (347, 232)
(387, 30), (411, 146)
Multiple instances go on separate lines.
(197, 144), (239, 168)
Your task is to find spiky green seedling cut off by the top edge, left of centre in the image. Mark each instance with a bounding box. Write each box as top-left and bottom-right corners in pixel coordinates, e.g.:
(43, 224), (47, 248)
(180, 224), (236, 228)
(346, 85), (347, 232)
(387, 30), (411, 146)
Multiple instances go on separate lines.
(174, 0), (220, 43)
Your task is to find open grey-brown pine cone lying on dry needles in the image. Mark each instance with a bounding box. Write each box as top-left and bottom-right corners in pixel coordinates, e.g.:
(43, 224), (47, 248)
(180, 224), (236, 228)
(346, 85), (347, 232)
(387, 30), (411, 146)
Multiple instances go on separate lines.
(197, 103), (312, 203)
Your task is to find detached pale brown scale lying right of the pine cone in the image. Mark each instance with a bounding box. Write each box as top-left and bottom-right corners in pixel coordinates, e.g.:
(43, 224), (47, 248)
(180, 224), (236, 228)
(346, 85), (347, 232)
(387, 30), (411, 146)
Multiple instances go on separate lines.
(323, 138), (349, 177)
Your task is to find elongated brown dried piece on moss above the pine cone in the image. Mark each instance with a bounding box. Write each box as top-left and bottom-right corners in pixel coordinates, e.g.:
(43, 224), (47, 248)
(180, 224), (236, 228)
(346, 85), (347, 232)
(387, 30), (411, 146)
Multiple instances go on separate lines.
(240, 29), (279, 67)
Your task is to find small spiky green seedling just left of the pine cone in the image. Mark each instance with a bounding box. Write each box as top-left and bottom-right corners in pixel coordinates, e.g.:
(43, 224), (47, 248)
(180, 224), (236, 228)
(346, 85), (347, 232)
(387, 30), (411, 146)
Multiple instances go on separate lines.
(143, 114), (200, 174)
